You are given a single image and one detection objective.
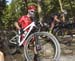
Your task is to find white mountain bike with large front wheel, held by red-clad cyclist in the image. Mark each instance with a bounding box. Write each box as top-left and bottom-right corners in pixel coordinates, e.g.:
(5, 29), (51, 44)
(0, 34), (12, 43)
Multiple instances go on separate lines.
(7, 21), (60, 61)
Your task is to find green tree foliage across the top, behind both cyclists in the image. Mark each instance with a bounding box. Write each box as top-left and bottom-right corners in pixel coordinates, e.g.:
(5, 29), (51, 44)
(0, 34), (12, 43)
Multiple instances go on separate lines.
(0, 0), (75, 29)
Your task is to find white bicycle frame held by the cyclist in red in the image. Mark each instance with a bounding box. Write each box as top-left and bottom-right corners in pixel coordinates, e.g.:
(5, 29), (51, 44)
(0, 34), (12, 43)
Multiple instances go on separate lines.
(9, 22), (36, 46)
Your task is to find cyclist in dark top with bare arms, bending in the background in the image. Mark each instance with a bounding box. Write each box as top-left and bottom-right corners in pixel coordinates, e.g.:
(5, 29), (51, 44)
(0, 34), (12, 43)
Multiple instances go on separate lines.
(43, 12), (66, 32)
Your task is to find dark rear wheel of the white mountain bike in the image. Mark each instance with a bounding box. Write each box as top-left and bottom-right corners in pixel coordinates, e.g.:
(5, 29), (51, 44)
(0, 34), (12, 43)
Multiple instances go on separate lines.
(4, 31), (17, 54)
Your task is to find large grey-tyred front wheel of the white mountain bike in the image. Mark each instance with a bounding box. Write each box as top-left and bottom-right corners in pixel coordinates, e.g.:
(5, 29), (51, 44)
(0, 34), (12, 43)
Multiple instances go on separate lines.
(24, 32), (60, 61)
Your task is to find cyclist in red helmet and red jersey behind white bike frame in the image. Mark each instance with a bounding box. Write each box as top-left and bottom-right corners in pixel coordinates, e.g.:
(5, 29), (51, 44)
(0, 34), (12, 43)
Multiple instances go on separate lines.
(15, 5), (36, 44)
